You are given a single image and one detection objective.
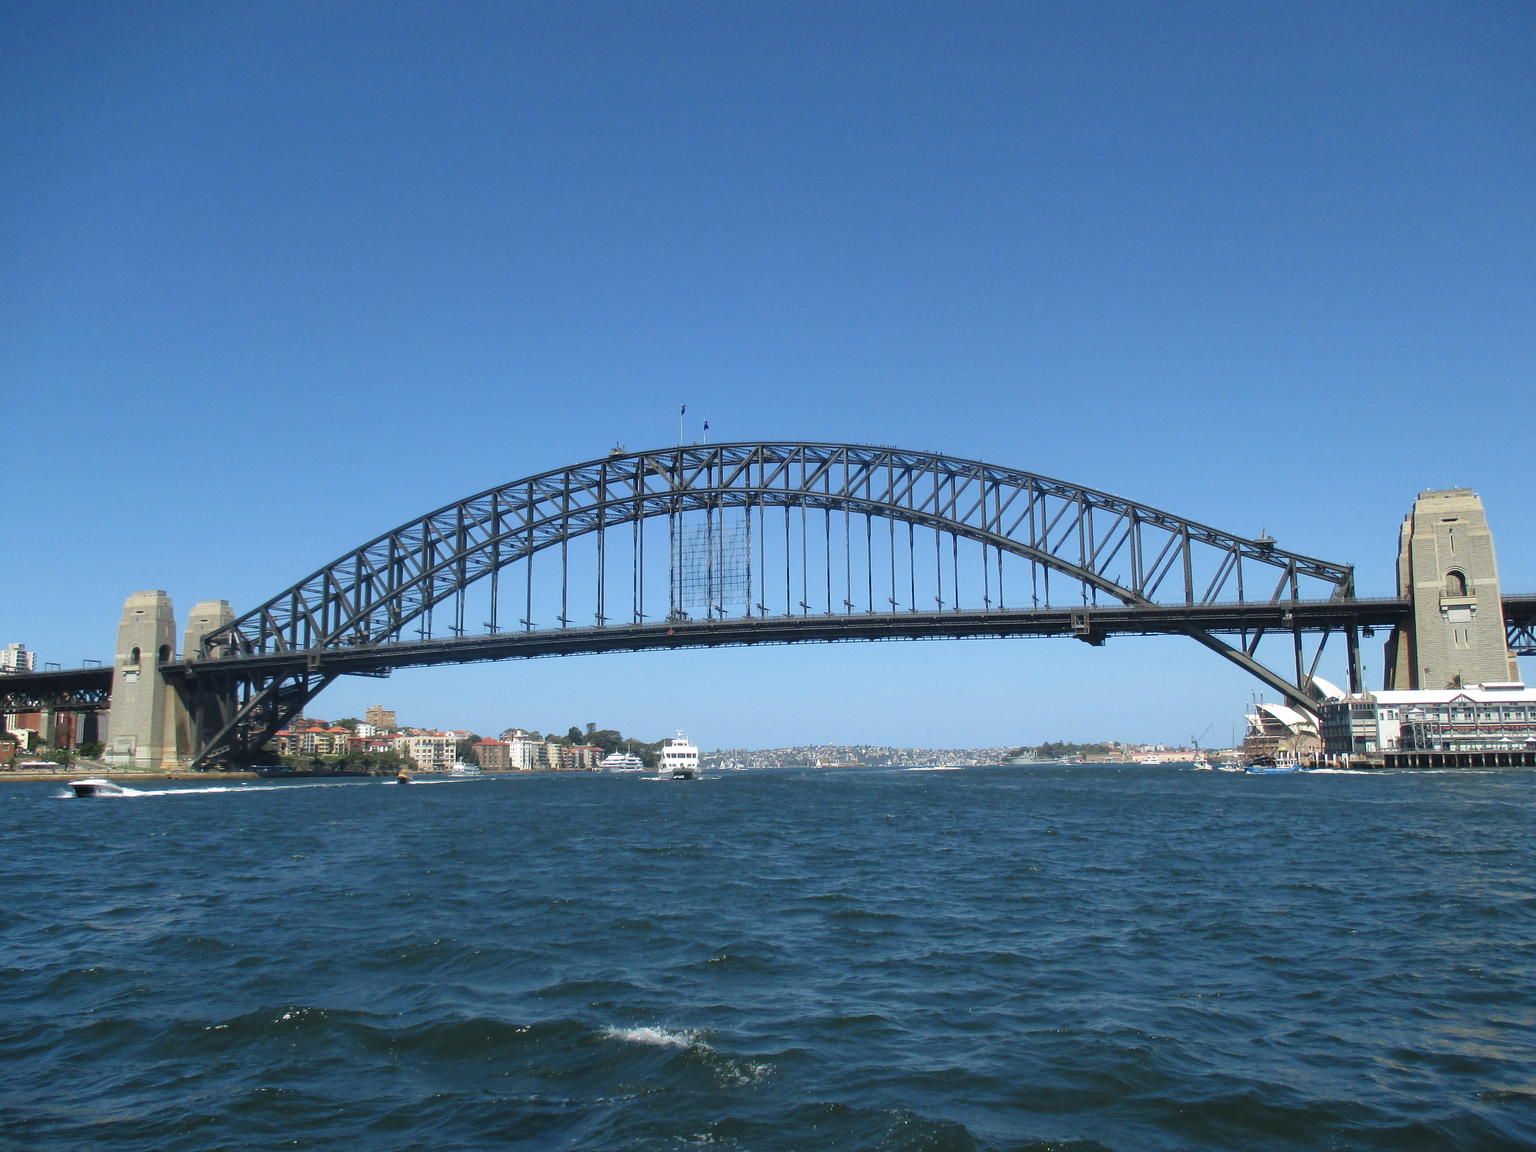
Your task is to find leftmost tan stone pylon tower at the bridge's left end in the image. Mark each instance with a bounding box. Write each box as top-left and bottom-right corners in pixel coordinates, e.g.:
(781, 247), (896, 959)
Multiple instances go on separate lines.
(106, 590), (181, 770)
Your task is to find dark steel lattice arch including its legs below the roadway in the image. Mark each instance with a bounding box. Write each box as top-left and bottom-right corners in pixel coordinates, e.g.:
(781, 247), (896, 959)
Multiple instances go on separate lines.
(179, 444), (1353, 763)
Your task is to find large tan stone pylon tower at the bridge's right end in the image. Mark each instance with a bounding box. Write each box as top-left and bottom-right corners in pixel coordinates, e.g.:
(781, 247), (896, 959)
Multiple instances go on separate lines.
(1384, 488), (1519, 691)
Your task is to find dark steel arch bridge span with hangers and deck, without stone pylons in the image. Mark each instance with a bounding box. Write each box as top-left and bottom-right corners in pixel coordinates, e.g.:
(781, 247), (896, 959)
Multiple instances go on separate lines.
(174, 442), (1363, 765)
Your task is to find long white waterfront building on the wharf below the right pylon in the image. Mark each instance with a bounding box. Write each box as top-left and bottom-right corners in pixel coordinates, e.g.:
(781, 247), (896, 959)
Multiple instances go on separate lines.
(1318, 680), (1536, 768)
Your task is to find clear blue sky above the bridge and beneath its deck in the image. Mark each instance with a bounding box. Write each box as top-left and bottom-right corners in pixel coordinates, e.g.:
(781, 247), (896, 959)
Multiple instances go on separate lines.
(0, 0), (1536, 746)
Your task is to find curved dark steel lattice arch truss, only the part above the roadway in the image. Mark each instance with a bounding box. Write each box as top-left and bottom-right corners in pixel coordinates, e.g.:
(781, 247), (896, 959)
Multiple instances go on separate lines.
(204, 444), (1353, 657)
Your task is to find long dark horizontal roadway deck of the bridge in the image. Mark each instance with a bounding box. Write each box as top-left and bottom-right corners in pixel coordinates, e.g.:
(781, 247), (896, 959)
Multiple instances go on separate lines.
(0, 593), (1536, 713)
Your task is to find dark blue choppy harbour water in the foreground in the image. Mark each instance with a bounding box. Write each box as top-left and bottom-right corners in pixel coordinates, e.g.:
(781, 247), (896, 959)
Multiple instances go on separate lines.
(0, 768), (1536, 1152)
